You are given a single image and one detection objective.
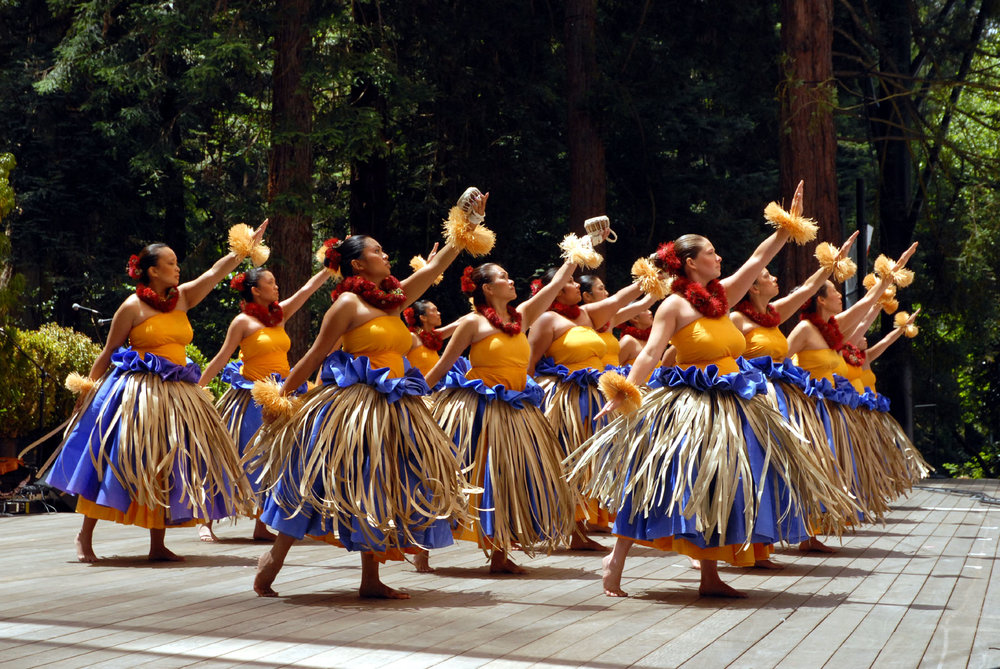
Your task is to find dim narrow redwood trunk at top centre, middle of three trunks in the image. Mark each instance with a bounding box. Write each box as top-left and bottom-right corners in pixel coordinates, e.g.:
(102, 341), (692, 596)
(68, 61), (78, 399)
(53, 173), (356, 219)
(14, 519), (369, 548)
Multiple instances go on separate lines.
(566, 0), (607, 240)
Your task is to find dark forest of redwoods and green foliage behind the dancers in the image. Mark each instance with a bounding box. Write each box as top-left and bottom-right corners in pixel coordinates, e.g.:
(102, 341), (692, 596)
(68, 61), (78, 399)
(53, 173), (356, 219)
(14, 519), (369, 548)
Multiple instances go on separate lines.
(0, 0), (1000, 477)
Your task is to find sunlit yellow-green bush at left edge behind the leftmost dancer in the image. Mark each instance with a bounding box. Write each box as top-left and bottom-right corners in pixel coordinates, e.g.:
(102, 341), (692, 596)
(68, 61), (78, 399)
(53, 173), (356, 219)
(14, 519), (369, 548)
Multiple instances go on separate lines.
(0, 323), (101, 438)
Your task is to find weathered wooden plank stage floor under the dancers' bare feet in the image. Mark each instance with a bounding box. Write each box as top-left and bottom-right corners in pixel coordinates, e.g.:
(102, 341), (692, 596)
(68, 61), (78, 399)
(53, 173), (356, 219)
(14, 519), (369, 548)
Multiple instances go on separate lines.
(0, 480), (1000, 669)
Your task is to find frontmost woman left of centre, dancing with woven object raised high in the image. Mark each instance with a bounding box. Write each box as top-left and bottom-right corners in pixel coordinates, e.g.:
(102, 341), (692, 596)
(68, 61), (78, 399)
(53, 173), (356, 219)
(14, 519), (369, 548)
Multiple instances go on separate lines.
(252, 189), (493, 599)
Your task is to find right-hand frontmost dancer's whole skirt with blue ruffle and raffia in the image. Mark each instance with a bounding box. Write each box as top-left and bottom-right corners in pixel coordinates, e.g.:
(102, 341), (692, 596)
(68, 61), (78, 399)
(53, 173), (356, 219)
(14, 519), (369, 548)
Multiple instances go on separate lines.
(566, 365), (824, 564)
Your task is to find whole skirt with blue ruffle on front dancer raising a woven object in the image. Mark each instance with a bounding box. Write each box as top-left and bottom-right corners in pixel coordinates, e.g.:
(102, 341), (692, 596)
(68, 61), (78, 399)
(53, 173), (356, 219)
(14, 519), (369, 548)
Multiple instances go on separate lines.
(244, 351), (465, 557)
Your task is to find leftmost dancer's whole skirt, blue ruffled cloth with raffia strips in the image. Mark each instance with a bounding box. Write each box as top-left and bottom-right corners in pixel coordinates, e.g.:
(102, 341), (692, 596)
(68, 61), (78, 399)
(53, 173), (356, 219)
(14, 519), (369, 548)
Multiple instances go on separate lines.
(47, 348), (253, 529)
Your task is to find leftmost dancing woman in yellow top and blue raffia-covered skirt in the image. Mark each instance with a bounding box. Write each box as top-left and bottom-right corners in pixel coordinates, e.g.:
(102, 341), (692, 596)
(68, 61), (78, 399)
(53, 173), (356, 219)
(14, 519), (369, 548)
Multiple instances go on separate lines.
(47, 221), (267, 562)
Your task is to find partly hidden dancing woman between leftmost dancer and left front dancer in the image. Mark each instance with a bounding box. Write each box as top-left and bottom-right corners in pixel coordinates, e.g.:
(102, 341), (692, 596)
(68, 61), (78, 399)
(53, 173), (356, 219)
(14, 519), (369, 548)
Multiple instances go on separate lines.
(190, 260), (330, 541)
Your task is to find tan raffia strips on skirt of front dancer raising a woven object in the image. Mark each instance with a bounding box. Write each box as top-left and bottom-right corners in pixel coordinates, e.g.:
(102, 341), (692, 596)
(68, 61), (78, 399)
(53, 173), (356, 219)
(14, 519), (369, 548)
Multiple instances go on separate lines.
(244, 383), (468, 547)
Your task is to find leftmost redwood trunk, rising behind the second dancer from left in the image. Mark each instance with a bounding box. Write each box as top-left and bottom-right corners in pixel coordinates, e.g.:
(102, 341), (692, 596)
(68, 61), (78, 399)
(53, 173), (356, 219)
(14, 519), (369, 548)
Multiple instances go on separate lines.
(267, 0), (313, 364)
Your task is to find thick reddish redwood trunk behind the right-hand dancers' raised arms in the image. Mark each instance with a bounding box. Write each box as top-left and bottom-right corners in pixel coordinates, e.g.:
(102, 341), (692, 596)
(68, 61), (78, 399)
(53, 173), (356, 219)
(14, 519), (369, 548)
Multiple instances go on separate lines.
(778, 0), (841, 291)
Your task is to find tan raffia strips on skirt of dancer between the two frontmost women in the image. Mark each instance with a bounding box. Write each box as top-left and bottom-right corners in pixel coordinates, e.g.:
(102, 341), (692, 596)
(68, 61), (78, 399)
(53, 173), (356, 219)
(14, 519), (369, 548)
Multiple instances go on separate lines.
(434, 388), (578, 555)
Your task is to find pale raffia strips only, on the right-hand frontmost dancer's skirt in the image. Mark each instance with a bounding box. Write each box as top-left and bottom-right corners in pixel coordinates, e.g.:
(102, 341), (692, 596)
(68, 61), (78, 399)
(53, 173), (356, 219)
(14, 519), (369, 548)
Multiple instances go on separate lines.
(564, 388), (802, 541)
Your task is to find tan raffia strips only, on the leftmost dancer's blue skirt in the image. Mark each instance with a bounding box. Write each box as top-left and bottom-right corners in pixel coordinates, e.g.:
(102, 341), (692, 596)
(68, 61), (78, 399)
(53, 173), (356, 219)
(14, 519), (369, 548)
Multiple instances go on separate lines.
(92, 373), (254, 518)
